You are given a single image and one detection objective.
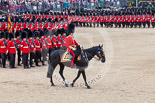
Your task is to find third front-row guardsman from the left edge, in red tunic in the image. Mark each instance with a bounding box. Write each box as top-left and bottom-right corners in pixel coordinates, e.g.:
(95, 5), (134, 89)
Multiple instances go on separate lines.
(20, 31), (30, 69)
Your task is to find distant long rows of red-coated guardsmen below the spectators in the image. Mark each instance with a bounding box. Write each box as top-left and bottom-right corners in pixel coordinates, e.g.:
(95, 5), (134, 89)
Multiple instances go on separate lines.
(0, 9), (155, 31)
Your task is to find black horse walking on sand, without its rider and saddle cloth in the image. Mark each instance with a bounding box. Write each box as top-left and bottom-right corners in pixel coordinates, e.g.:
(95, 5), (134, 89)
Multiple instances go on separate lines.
(47, 45), (105, 89)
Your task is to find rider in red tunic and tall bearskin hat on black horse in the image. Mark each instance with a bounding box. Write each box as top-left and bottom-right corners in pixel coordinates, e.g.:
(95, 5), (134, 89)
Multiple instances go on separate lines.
(63, 24), (79, 68)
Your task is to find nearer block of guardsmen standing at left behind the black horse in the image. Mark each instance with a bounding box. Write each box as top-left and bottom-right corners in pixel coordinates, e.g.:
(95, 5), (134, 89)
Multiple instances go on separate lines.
(0, 28), (66, 69)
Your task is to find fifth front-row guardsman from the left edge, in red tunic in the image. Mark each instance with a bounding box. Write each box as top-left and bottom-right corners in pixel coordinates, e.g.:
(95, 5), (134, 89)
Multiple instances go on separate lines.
(34, 31), (41, 66)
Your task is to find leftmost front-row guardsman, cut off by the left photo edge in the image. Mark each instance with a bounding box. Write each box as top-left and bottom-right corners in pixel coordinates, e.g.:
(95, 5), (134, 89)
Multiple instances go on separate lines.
(0, 32), (7, 68)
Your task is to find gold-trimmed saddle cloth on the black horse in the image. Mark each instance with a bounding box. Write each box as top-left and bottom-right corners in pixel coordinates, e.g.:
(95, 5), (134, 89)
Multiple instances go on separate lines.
(60, 50), (81, 62)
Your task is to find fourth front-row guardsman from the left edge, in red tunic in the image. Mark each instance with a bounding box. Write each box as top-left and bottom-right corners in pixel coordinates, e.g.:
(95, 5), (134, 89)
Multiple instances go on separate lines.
(28, 31), (35, 67)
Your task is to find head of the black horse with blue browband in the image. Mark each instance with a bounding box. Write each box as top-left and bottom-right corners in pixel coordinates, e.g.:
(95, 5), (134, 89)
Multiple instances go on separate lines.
(96, 45), (106, 63)
